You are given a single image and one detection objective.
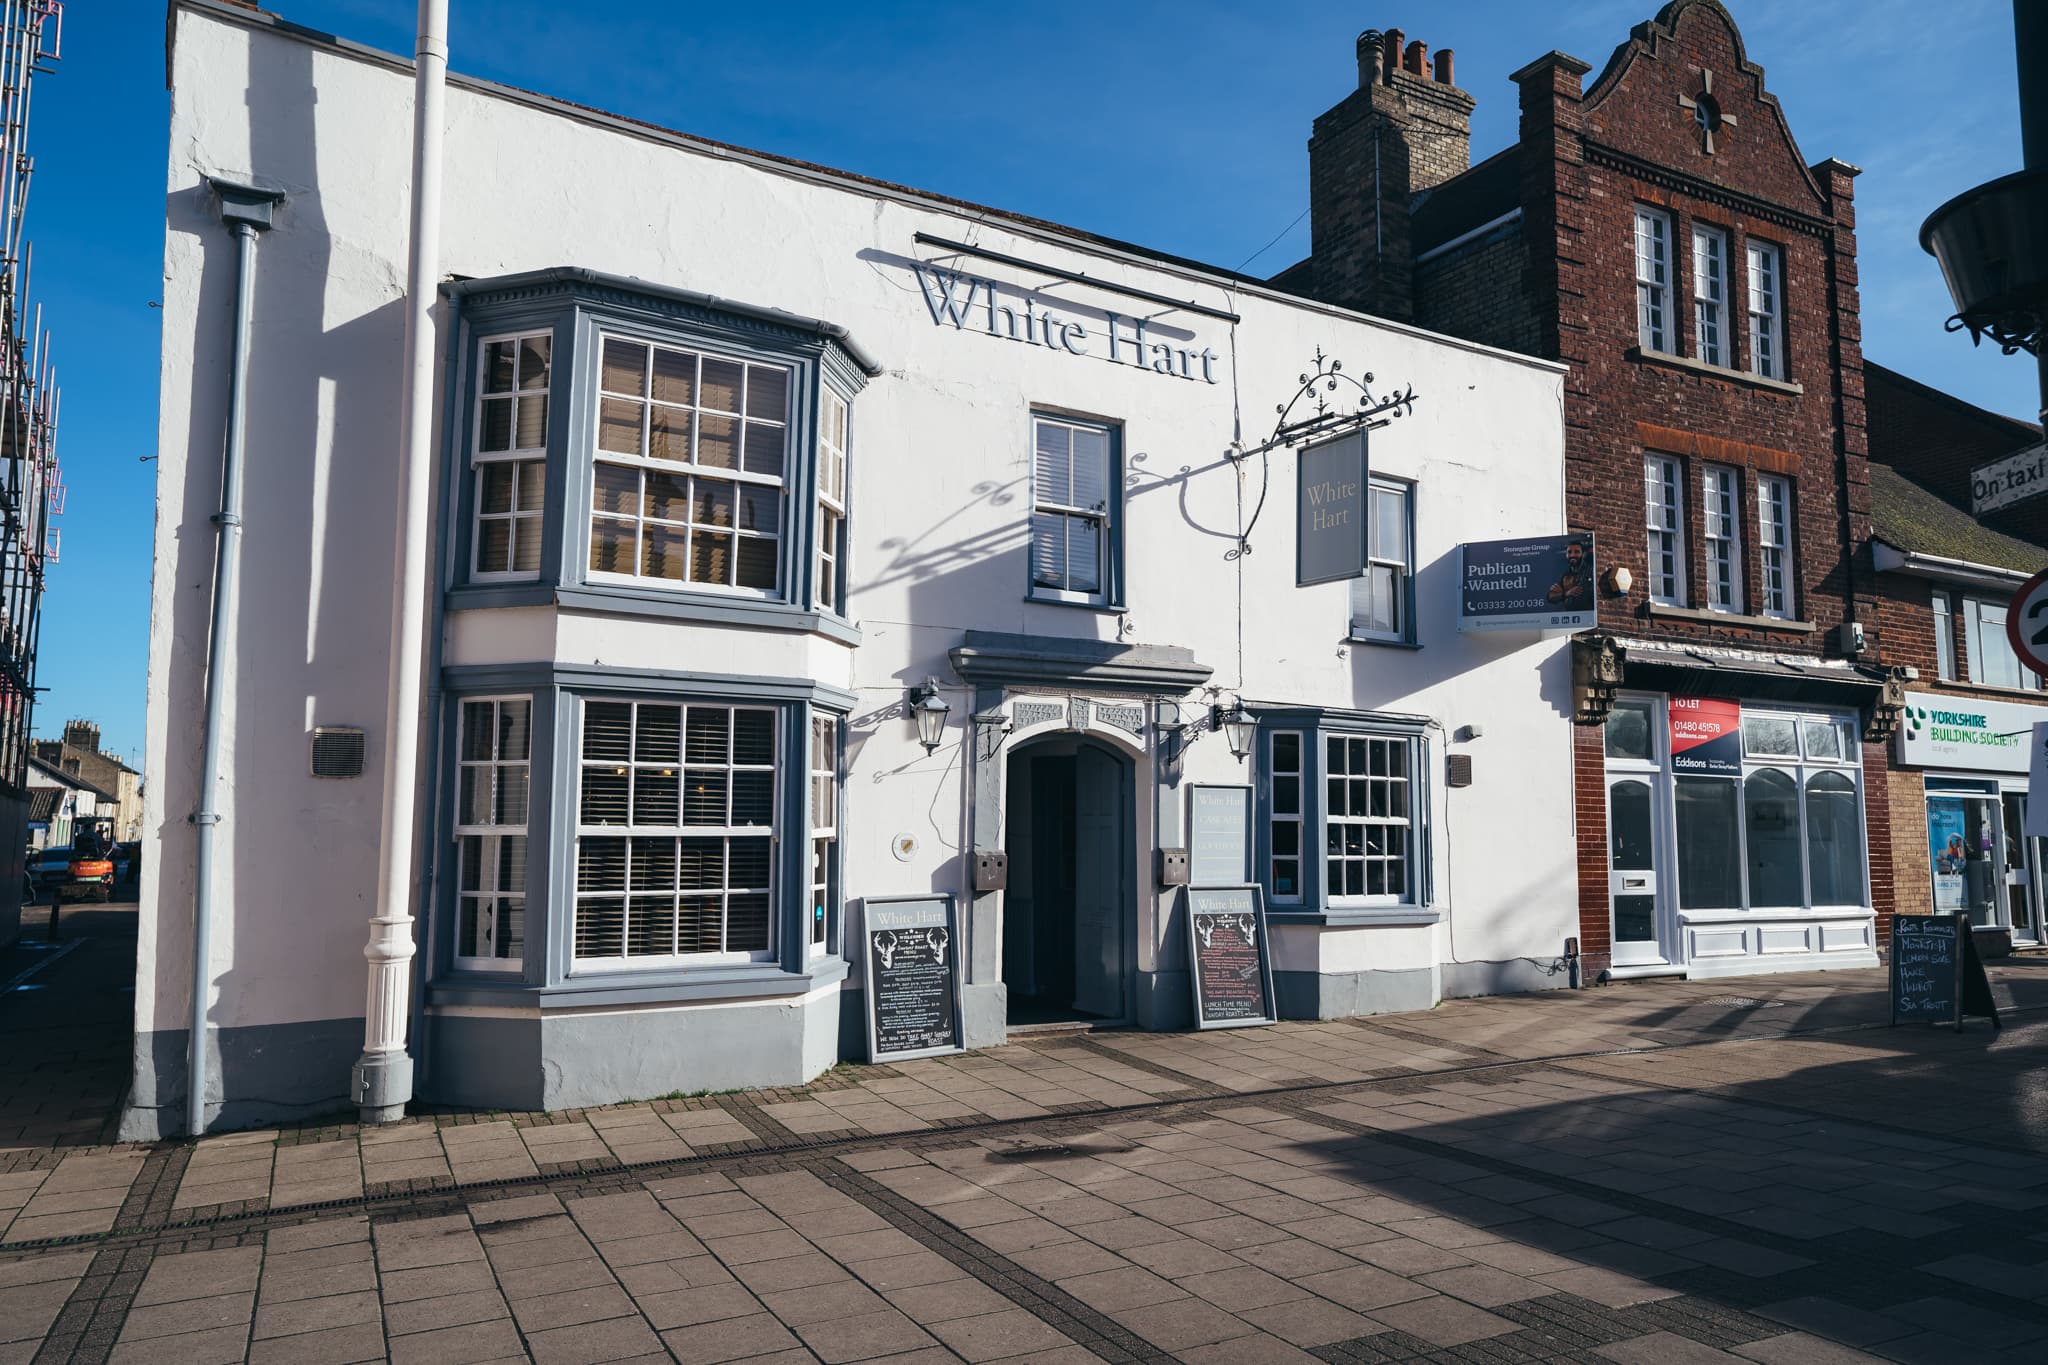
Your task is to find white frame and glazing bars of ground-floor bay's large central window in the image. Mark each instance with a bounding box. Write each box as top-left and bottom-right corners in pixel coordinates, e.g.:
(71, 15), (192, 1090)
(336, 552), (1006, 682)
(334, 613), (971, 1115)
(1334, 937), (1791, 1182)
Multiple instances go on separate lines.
(569, 696), (784, 972)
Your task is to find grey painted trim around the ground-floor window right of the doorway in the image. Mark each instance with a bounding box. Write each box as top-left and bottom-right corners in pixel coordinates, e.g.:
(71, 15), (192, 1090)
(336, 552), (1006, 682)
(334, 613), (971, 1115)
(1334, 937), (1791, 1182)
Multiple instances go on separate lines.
(1249, 702), (1442, 927)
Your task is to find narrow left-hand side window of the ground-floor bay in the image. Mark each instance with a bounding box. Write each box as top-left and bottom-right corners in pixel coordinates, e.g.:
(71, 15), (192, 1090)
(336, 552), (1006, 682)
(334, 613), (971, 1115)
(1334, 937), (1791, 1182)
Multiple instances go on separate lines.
(455, 698), (532, 970)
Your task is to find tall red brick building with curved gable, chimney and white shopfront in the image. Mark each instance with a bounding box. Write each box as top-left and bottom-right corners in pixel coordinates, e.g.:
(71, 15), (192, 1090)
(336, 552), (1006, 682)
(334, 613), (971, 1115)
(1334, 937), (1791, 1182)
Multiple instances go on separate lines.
(1278, 0), (1903, 976)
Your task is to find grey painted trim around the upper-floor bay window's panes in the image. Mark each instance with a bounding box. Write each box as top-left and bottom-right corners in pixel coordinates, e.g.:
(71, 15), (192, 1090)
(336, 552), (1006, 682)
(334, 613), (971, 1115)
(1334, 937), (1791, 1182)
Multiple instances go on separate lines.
(442, 270), (872, 645)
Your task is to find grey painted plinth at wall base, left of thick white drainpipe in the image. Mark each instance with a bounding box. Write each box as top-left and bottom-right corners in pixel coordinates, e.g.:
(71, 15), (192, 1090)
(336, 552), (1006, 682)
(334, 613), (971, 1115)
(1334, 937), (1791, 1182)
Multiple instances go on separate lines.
(117, 1019), (362, 1142)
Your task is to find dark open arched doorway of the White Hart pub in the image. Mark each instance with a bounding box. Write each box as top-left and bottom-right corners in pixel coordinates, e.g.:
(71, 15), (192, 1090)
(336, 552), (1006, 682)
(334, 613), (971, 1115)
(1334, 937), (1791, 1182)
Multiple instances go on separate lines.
(1004, 737), (1137, 1027)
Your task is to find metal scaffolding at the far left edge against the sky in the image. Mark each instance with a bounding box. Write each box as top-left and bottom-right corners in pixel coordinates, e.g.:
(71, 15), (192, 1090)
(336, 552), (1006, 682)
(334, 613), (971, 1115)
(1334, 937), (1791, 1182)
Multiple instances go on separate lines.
(0, 0), (63, 794)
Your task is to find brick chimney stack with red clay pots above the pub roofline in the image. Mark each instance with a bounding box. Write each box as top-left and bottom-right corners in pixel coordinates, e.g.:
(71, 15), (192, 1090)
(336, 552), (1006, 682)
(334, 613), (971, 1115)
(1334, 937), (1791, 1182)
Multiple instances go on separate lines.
(1309, 29), (1473, 321)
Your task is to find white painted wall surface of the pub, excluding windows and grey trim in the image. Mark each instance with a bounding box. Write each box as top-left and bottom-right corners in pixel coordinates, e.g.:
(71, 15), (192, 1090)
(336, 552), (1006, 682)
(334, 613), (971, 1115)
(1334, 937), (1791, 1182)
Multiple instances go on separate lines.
(137, 8), (1575, 1055)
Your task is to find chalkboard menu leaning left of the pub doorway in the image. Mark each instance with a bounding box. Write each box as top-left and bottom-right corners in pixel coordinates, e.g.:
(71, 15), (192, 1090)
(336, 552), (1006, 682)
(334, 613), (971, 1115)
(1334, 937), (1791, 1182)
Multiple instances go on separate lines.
(860, 896), (961, 1062)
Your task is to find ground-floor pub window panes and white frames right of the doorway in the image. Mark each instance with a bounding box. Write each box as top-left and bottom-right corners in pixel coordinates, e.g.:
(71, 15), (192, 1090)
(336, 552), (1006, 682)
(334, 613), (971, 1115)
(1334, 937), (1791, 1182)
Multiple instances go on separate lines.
(1260, 726), (1427, 911)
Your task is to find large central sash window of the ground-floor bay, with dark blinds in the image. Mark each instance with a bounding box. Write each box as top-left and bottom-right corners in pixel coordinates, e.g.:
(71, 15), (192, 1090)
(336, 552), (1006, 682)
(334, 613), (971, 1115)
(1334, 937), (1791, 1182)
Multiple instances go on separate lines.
(573, 700), (778, 966)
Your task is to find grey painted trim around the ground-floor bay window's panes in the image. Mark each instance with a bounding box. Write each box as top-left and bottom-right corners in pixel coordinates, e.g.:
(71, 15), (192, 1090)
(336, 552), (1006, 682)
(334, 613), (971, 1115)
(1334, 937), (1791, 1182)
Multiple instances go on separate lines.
(428, 663), (856, 1009)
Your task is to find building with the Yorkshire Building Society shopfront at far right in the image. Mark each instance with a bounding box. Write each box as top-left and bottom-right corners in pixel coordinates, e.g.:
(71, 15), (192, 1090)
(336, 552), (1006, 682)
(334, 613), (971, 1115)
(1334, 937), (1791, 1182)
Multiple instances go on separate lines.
(1864, 364), (2048, 952)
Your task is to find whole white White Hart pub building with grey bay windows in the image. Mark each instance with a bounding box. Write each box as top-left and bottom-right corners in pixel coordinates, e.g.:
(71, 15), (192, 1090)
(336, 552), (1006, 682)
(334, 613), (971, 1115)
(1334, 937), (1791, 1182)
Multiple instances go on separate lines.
(140, 0), (1577, 1138)
